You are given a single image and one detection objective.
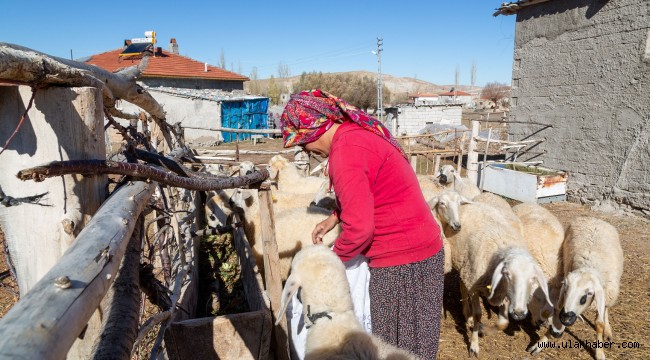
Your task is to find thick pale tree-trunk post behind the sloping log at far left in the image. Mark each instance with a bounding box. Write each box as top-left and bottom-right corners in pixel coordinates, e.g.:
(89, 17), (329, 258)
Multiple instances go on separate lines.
(0, 86), (107, 358)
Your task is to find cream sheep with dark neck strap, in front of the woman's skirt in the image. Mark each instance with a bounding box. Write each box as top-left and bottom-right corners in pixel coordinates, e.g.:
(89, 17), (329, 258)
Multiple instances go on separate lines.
(275, 245), (418, 360)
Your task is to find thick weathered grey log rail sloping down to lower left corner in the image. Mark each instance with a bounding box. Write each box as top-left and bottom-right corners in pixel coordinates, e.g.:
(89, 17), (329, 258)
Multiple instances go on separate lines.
(0, 182), (156, 359)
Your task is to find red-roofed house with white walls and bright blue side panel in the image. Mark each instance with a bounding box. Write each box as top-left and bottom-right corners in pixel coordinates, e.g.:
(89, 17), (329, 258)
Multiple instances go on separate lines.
(85, 38), (268, 145)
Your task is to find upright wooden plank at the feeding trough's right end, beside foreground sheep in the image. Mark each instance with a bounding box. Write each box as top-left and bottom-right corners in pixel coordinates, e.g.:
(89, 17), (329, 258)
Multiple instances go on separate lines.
(258, 182), (290, 360)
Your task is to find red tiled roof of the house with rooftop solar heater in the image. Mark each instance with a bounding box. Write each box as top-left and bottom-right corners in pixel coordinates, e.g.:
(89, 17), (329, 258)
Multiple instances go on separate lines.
(86, 49), (250, 81)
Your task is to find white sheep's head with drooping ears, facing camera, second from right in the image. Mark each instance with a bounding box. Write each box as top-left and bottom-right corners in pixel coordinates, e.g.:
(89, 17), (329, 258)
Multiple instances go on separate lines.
(488, 247), (553, 321)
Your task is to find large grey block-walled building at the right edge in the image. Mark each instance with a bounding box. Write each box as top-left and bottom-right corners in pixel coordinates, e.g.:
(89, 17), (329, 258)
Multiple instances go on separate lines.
(494, 0), (650, 215)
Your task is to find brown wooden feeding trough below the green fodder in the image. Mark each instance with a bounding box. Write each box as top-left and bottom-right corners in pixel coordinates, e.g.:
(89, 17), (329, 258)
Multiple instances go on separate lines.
(165, 228), (273, 360)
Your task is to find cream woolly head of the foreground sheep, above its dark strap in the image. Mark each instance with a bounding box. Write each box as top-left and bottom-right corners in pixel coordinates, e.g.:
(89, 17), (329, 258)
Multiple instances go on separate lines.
(276, 245), (353, 325)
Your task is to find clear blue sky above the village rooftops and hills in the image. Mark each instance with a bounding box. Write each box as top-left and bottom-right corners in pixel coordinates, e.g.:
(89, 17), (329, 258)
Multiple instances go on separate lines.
(0, 0), (515, 86)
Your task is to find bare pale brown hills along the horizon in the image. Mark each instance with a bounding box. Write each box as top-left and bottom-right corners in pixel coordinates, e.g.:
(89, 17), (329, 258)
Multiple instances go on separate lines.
(244, 71), (481, 104)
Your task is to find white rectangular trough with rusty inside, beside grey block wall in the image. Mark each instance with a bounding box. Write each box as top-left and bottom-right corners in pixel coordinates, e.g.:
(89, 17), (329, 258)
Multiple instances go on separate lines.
(479, 163), (569, 203)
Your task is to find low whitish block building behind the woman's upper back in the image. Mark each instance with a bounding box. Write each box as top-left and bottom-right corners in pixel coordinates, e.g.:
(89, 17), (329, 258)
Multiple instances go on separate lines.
(386, 104), (463, 136)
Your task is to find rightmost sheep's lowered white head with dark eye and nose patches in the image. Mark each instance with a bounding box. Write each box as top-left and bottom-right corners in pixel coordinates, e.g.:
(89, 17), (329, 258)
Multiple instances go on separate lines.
(558, 268), (605, 326)
